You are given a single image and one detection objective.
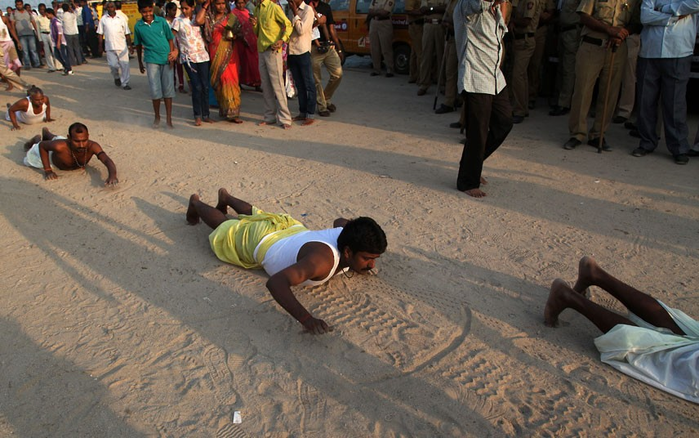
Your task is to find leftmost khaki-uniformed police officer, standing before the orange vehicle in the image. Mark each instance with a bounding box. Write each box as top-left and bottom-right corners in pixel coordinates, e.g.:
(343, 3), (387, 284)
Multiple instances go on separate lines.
(367, 0), (396, 78)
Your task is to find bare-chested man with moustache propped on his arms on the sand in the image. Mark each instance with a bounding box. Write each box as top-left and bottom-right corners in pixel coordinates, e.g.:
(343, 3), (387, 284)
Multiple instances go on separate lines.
(24, 123), (119, 186)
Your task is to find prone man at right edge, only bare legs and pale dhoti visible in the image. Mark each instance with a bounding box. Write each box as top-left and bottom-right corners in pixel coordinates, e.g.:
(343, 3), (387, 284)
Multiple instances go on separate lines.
(544, 257), (699, 403)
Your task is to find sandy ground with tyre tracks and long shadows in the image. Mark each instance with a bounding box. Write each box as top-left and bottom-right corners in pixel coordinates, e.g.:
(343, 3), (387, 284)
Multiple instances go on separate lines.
(0, 56), (699, 437)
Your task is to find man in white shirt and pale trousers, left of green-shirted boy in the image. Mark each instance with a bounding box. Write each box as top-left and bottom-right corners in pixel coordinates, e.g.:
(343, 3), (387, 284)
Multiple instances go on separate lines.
(97, 2), (131, 90)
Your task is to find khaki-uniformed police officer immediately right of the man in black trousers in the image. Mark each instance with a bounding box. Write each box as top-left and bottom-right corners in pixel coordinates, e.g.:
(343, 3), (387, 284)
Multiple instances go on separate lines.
(511, 0), (545, 123)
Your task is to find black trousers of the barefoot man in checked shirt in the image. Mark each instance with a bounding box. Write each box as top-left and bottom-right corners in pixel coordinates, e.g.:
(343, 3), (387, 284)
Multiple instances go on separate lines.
(456, 87), (512, 191)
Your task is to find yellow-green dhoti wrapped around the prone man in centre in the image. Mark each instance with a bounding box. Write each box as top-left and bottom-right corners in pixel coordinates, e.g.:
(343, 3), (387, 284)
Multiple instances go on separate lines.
(209, 207), (308, 269)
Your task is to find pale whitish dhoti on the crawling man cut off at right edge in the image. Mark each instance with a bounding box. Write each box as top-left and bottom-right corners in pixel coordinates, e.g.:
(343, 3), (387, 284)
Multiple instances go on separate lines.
(595, 301), (699, 403)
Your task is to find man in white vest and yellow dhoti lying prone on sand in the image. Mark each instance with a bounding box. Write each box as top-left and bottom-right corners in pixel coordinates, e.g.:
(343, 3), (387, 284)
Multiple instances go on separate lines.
(187, 188), (386, 334)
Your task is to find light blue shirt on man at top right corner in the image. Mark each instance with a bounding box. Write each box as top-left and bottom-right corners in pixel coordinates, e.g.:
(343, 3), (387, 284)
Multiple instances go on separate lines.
(638, 0), (699, 58)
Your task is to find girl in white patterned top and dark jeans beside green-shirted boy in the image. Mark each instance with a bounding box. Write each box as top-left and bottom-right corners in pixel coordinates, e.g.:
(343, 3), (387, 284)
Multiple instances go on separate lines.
(172, 0), (214, 126)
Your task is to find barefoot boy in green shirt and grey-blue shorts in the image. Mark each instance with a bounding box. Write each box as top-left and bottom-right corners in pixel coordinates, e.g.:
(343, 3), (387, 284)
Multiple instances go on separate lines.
(134, 0), (178, 128)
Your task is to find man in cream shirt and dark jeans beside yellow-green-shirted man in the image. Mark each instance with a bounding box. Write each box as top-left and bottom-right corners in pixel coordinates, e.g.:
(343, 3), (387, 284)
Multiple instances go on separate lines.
(287, 0), (316, 126)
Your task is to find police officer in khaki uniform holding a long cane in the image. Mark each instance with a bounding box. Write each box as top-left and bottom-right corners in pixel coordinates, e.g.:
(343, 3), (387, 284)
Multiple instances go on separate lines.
(563, 0), (641, 151)
